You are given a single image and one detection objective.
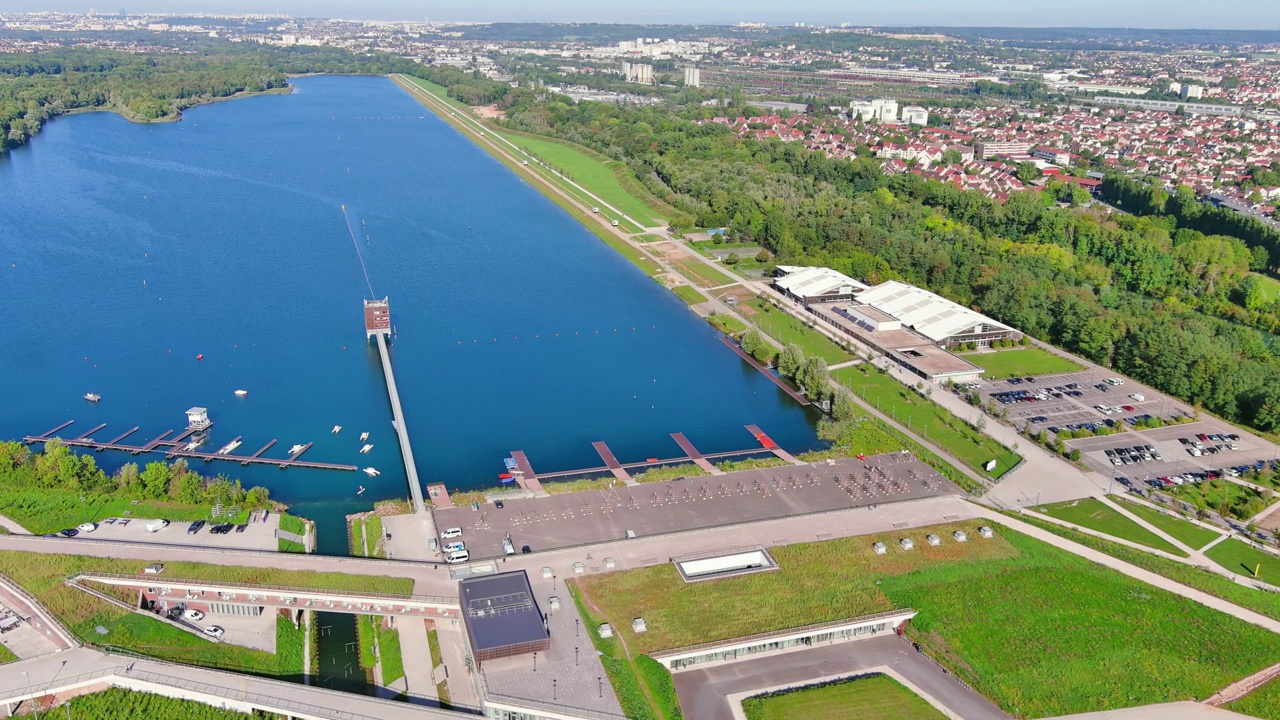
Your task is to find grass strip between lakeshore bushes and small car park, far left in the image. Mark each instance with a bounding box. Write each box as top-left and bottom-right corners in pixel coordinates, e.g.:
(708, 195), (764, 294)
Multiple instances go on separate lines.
(0, 488), (248, 536)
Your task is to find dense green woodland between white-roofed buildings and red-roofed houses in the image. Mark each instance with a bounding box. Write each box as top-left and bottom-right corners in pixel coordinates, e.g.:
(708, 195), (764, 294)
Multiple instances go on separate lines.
(494, 97), (1280, 430)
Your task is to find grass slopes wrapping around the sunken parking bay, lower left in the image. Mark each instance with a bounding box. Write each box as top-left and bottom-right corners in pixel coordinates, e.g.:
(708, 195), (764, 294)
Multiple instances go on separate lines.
(0, 551), (413, 676)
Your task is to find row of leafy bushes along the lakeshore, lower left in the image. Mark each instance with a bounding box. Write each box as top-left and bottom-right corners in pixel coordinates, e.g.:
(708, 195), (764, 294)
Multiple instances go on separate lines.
(0, 441), (270, 507)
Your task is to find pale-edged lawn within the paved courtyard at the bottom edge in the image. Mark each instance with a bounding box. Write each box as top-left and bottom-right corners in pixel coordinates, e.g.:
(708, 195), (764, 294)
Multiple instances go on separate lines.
(742, 674), (946, 720)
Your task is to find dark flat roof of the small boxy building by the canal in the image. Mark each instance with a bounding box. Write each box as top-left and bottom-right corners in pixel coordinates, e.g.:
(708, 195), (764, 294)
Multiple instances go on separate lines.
(458, 570), (550, 651)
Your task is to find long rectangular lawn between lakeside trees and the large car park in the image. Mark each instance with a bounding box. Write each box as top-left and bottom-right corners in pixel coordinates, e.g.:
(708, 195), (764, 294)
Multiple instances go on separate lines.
(832, 363), (1020, 478)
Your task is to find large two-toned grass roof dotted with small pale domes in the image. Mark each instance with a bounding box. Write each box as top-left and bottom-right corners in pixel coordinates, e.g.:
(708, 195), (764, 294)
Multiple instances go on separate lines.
(572, 523), (1280, 717)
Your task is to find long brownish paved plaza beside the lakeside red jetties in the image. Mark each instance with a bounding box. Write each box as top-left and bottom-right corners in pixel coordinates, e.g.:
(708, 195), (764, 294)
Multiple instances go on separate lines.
(435, 454), (964, 560)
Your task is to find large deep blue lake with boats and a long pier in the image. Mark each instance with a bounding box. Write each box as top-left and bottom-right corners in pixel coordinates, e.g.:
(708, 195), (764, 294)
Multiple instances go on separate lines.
(0, 77), (819, 540)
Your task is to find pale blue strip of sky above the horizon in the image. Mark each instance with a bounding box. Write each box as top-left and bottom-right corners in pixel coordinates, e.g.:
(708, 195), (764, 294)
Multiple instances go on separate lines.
(10, 0), (1280, 29)
